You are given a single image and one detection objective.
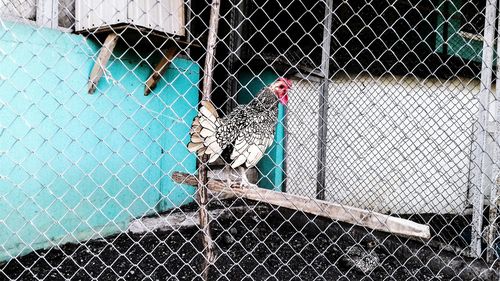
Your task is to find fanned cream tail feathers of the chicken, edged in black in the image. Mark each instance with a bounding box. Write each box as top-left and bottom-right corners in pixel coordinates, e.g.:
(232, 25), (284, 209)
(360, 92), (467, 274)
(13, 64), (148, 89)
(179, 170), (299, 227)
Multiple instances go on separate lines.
(188, 101), (223, 163)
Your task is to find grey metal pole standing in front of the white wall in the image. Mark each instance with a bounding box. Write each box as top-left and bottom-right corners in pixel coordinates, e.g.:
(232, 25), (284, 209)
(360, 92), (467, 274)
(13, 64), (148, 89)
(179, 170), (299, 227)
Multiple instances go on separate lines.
(316, 0), (333, 200)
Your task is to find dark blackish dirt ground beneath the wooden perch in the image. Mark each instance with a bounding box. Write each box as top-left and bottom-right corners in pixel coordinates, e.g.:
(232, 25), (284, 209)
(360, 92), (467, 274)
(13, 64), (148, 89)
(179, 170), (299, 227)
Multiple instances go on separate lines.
(0, 199), (498, 281)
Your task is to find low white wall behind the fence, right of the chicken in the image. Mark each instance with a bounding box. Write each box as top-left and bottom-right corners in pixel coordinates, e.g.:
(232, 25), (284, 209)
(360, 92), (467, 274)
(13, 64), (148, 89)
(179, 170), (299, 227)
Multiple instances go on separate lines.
(287, 75), (479, 213)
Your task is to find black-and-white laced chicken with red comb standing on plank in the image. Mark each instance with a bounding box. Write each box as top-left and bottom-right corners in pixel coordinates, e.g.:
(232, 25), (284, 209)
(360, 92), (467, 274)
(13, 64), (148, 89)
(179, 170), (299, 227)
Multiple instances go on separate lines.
(187, 77), (292, 187)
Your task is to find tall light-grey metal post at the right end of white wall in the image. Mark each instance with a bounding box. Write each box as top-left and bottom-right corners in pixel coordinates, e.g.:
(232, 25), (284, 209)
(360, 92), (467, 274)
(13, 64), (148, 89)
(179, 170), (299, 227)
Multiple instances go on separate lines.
(471, 0), (497, 257)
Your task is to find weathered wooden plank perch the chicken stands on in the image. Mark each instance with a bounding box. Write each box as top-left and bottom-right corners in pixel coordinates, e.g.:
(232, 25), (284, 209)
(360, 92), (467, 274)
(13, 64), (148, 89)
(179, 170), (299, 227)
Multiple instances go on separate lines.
(172, 172), (431, 239)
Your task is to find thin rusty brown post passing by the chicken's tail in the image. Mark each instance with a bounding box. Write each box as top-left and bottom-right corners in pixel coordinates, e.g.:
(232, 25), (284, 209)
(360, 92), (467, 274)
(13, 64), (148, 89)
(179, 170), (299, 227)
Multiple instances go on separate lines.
(196, 0), (220, 280)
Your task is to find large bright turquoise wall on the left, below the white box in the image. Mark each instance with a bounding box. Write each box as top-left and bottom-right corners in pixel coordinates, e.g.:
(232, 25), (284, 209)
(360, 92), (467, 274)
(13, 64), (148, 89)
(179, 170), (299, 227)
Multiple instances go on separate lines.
(0, 23), (199, 260)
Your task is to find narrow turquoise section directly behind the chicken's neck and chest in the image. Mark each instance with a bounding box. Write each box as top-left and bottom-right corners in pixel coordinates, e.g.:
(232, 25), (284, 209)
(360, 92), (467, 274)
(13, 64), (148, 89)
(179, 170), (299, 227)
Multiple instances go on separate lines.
(238, 69), (285, 191)
